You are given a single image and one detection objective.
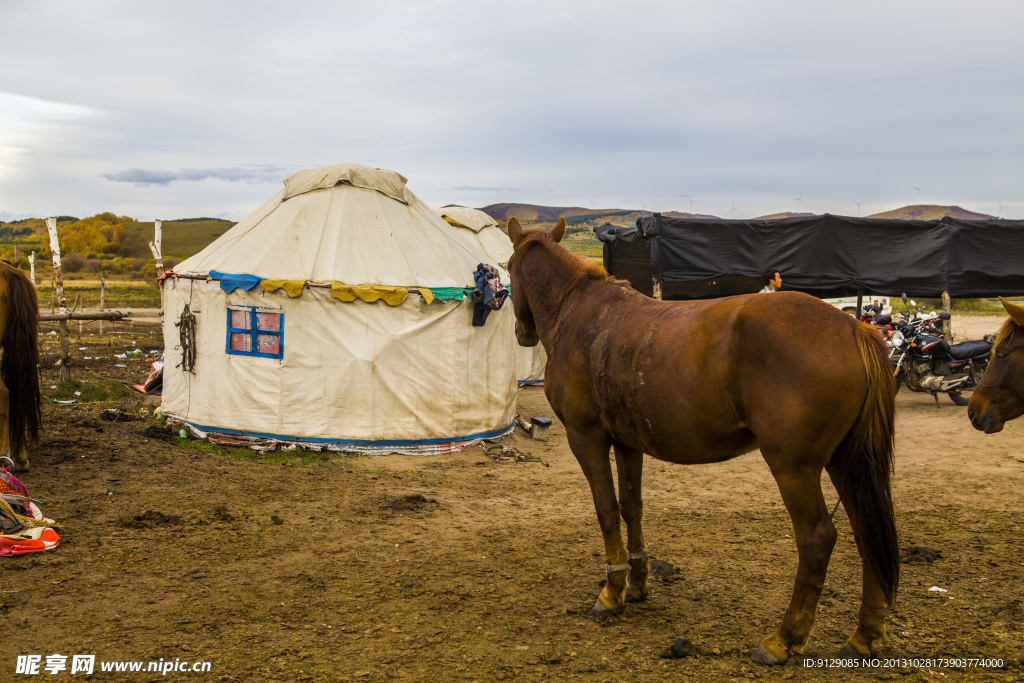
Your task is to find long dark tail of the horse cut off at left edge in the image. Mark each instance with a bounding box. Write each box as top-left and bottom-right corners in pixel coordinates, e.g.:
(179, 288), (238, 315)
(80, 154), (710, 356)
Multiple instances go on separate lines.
(0, 264), (42, 455)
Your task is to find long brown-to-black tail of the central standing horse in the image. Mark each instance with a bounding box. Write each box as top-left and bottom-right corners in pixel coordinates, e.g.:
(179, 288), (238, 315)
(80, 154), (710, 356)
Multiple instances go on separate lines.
(828, 323), (899, 604)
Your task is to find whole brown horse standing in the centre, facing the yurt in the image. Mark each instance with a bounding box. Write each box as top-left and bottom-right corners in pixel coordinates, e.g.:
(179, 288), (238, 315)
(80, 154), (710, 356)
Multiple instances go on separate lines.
(508, 218), (899, 664)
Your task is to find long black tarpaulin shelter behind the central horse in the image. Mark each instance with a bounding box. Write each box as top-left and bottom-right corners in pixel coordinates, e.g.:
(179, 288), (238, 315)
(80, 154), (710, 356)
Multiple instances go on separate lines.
(596, 214), (1024, 298)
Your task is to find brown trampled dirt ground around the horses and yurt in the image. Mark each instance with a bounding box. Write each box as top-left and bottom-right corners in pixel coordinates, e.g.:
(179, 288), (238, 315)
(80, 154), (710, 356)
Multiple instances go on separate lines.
(0, 317), (1024, 682)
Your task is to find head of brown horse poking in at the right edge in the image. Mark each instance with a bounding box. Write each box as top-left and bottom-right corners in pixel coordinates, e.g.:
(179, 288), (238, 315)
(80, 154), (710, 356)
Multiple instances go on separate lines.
(967, 297), (1024, 434)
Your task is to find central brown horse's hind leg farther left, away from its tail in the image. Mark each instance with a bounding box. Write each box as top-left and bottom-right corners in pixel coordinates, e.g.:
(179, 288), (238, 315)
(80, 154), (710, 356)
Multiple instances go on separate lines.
(751, 466), (836, 665)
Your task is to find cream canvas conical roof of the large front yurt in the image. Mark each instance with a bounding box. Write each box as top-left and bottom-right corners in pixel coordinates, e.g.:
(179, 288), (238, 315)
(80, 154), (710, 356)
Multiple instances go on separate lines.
(174, 164), (487, 287)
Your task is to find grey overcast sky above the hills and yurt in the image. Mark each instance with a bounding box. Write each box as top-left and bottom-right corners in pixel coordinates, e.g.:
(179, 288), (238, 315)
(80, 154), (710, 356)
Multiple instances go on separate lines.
(0, 0), (1024, 220)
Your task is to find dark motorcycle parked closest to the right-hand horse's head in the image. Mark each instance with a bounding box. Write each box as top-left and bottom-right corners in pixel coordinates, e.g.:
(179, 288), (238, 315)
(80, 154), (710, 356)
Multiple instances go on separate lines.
(889, 294), (992, 405)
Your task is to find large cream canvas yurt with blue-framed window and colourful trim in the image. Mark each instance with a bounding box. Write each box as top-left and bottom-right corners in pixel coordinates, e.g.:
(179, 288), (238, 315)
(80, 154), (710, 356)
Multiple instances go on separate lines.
(162, 164), (516, 453)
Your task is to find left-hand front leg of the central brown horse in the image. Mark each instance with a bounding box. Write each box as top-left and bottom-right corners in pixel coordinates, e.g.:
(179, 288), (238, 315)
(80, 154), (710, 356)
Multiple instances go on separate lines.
(565, 426), (630, 616)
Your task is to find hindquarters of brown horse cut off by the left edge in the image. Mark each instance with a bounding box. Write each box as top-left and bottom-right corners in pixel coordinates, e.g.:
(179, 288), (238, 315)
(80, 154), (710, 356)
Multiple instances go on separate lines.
(0, 261), (40, 471)
